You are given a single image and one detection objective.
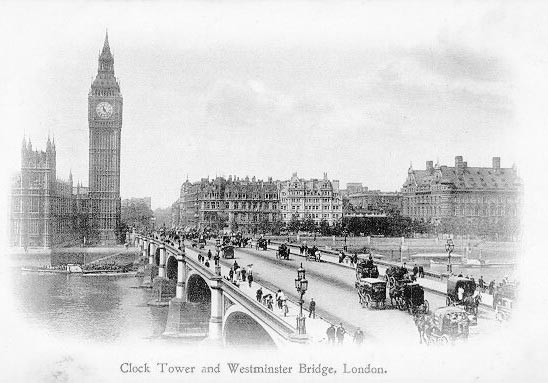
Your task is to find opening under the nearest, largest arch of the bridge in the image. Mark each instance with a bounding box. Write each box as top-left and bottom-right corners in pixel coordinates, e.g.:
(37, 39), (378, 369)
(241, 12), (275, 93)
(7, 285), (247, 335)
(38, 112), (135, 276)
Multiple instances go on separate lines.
(225, 311), (276, 348)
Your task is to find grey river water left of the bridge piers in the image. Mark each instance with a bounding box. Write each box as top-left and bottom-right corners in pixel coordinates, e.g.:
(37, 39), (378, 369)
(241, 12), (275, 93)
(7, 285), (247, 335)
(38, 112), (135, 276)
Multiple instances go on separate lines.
(9, 256), (167, 342)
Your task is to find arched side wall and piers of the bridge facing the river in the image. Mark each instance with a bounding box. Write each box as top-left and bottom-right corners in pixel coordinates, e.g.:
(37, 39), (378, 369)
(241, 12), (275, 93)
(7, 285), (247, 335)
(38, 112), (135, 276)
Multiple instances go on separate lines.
(132, 234), (309, 347)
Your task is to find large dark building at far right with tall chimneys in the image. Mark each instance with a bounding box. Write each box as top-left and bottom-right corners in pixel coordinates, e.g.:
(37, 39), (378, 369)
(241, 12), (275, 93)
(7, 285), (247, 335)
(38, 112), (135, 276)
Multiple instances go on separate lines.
(402, 156), (522, 234)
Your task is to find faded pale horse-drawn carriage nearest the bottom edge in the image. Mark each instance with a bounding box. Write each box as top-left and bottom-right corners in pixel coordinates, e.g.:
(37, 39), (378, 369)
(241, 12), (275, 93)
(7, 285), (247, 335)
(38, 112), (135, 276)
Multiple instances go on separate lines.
(425, 306), (470, 344)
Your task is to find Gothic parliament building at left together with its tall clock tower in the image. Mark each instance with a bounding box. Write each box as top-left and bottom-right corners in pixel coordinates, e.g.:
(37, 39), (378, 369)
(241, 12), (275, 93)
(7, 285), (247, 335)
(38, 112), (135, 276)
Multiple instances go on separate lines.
(10, 34), (123, 249)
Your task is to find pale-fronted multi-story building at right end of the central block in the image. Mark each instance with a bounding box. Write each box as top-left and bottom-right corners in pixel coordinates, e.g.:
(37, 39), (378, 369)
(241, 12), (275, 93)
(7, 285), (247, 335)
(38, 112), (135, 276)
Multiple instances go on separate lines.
(279, 173), (342, 225)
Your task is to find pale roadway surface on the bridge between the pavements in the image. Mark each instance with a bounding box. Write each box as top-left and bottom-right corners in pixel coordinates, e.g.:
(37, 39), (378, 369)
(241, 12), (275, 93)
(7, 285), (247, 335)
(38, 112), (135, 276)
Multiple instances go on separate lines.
(202, 244), (495, 345)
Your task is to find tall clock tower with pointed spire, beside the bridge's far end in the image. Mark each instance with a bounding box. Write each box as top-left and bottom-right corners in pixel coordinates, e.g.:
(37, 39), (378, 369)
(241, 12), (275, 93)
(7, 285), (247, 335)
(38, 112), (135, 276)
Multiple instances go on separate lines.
(88, 32), (123, 245)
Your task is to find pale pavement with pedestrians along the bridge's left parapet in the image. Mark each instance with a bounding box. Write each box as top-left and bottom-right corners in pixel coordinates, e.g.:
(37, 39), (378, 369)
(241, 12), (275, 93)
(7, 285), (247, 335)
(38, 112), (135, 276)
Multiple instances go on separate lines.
(186, 245), (353, 345)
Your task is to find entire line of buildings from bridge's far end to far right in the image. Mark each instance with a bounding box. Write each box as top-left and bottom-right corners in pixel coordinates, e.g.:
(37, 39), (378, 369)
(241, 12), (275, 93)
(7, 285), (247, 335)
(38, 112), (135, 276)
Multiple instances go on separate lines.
(172, 156), (522, 234)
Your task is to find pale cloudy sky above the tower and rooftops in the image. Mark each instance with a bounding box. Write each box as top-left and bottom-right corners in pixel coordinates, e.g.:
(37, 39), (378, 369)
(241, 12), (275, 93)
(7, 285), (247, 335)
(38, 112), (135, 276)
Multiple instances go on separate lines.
(0, 1), (525, 208)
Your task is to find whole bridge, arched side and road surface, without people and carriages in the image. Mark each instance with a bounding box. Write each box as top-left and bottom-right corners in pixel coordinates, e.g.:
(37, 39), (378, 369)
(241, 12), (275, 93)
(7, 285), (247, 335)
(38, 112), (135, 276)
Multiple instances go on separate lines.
(132, 235), (500, 346)
